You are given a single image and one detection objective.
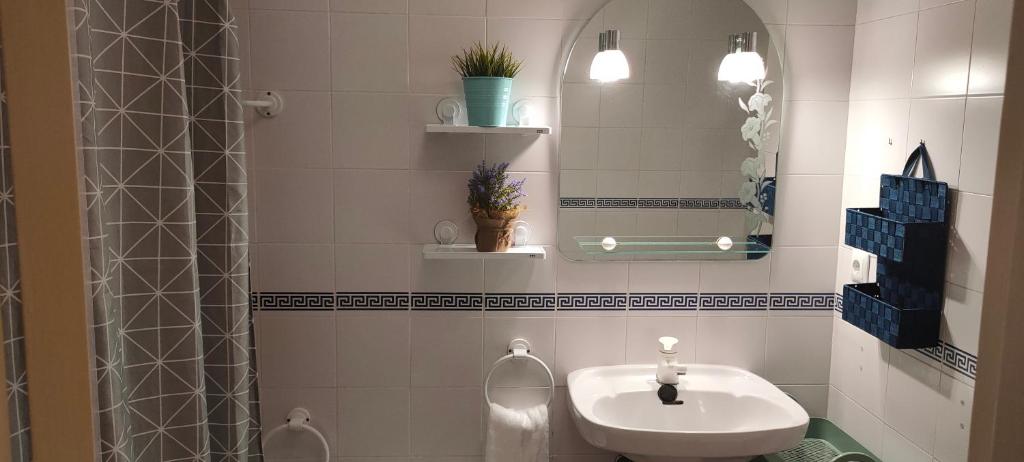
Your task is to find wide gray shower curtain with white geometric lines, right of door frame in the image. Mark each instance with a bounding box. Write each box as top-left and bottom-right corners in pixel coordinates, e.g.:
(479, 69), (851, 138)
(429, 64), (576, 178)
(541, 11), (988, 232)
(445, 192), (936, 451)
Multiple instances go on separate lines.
(72, 0), (262, 462)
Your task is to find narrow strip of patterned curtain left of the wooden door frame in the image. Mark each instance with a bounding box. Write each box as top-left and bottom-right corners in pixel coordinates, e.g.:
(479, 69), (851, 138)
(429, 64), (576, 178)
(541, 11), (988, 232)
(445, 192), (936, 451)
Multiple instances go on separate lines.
(0, 37), (32, 462)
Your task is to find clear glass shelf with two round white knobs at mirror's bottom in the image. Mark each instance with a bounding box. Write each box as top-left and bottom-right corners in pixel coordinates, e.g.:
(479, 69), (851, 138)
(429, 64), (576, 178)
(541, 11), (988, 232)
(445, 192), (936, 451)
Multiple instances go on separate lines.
(566, 236), (771, 261)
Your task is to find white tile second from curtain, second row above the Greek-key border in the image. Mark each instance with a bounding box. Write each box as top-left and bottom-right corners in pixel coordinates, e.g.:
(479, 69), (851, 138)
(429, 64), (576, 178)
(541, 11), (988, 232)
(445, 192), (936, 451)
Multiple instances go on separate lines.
(334, 170), (409, 244)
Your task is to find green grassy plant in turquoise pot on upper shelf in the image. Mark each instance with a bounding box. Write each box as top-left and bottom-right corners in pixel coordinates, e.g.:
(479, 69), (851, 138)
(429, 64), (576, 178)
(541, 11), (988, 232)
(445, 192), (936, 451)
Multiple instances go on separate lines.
(452, 42), (522, 127)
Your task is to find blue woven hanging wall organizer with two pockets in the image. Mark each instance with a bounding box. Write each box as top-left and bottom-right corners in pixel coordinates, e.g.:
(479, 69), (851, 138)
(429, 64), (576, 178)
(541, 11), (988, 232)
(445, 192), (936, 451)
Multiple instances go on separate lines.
(843, 142), (949, 348)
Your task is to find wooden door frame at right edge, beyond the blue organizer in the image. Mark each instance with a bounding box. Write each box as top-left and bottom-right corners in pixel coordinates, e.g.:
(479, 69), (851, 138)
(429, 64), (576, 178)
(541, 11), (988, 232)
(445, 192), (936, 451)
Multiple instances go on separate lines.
(970, 0), (1024, 462)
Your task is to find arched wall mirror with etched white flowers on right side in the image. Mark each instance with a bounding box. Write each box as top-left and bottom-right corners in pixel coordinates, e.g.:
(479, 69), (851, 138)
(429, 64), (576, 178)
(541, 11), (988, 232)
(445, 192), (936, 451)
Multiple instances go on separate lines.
(558, 0), (784, 261)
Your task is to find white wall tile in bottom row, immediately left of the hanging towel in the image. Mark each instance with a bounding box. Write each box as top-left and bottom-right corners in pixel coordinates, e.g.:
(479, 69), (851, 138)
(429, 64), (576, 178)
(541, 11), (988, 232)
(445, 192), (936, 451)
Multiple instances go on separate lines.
(410, 388), (483, 456)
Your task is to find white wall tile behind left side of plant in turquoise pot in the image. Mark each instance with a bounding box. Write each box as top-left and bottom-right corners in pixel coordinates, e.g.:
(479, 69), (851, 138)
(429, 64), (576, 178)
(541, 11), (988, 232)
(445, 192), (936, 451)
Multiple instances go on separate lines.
(409, 16), (485, 94)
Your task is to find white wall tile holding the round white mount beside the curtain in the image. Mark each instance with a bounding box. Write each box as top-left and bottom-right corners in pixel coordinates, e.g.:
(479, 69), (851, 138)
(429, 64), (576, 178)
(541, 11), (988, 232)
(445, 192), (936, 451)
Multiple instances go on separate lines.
(251, 91), (331, 168)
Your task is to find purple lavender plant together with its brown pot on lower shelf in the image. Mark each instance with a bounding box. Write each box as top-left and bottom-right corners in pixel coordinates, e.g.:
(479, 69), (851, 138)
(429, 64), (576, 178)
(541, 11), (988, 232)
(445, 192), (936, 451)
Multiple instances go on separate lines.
(467, 162), (526, 252)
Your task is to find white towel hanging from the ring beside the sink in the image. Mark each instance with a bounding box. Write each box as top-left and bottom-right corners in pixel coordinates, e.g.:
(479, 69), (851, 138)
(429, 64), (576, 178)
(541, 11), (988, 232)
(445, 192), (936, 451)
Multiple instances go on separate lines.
(484, 405), (548, 462)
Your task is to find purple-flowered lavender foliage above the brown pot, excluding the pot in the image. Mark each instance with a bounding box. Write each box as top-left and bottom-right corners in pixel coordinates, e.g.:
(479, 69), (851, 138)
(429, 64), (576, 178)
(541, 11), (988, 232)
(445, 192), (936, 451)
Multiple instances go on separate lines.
(466, 162), (526, 217)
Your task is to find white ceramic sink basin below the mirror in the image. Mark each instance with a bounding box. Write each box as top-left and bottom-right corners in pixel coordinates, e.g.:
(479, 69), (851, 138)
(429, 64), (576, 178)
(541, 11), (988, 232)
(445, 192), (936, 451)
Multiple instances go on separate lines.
(567, 365), (810, 462)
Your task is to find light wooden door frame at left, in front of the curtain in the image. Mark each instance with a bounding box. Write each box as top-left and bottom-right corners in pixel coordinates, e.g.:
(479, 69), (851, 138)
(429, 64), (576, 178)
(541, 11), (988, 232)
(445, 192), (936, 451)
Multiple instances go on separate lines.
(0, 0), (97, 462)
